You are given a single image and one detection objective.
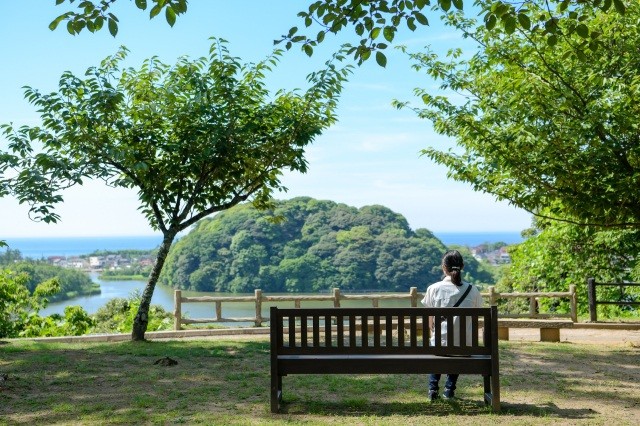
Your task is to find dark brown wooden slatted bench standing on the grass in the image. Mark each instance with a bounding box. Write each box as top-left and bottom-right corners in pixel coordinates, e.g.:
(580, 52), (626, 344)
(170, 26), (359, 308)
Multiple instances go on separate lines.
(270, 306), (500, 413)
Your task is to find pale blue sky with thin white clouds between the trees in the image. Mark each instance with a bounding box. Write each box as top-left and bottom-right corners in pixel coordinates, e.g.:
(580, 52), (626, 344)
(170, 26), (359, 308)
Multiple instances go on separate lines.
(0, 0), (531, 239)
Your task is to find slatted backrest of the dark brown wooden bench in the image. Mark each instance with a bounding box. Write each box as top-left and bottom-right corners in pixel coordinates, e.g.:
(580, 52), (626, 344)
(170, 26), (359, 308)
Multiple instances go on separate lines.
(270, 306), (498, 355)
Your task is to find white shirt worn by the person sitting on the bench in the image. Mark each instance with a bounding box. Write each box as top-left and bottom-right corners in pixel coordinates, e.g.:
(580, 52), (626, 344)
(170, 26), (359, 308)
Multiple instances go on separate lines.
(422, 276), (483, 346)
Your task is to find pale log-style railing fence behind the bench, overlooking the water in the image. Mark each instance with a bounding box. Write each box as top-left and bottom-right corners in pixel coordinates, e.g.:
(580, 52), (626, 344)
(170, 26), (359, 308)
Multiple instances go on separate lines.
(173, 285), (577, 330)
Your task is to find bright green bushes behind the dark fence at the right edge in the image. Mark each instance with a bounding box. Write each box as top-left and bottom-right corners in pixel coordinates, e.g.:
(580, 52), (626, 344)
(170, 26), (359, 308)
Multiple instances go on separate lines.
(498, 220), (640, 317)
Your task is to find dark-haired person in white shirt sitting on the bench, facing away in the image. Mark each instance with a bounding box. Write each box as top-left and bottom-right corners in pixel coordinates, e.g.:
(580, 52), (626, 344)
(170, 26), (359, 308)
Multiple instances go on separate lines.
(422, 250), (483, 401)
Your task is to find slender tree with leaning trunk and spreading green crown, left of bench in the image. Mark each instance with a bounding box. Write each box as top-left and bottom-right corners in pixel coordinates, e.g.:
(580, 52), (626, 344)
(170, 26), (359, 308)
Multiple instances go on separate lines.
(2, 39), (349, 340)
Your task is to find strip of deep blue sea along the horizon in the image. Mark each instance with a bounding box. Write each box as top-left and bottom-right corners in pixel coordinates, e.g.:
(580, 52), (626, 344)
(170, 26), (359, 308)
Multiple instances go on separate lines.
(0, 232), (523, 259)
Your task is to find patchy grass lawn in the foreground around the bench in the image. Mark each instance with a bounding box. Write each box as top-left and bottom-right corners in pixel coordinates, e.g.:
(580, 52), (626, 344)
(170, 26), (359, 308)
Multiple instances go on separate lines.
(0, 337), (640, 426)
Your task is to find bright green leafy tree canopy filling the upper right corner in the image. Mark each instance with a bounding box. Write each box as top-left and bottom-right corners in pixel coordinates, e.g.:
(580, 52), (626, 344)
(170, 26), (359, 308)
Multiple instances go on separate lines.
(397, 2), (640, 228)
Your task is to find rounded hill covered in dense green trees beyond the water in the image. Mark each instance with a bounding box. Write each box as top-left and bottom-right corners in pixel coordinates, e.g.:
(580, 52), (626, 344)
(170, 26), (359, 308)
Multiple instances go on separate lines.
(160, 197), (491, 292)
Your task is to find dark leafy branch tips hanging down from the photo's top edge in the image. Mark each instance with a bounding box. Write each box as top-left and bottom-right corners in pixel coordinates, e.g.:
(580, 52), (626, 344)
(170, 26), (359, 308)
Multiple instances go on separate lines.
(49, 0), (627, 67)
